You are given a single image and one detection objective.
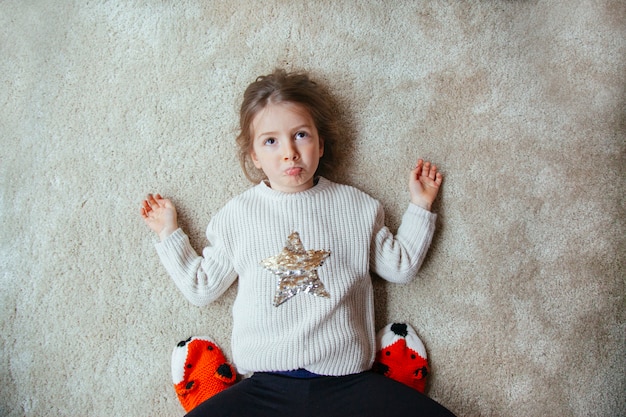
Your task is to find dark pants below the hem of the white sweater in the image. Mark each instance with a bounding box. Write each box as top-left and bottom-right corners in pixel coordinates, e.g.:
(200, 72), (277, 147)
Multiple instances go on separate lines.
(187, 372), (454, 417)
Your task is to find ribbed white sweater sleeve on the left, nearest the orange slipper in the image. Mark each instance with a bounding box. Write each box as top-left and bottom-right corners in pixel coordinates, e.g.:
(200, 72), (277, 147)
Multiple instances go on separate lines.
(155, 229), (237, 306)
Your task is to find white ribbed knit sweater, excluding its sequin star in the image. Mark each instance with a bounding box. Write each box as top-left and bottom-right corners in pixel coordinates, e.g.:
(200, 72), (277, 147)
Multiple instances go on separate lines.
(156, 178), (436, 375)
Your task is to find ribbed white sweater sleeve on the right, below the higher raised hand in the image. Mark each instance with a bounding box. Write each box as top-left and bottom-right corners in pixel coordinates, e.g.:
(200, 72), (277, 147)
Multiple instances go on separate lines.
(370, 204), (437, 283)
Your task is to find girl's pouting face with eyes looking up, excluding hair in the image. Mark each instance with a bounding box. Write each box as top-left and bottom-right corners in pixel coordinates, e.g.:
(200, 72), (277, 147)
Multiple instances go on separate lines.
(250, 102), (324, 193)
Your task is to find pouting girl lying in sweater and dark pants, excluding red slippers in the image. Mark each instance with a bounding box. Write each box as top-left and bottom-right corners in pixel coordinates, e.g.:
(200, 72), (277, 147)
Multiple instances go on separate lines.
(141, 70), (452, 417)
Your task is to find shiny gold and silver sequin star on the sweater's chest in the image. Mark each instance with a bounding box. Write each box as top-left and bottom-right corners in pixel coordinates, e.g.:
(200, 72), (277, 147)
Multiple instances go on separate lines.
(261, 232), (330, 307)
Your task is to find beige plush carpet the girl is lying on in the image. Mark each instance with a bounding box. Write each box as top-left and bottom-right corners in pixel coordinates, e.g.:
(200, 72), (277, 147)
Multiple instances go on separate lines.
(0, 0), (626, 417)
